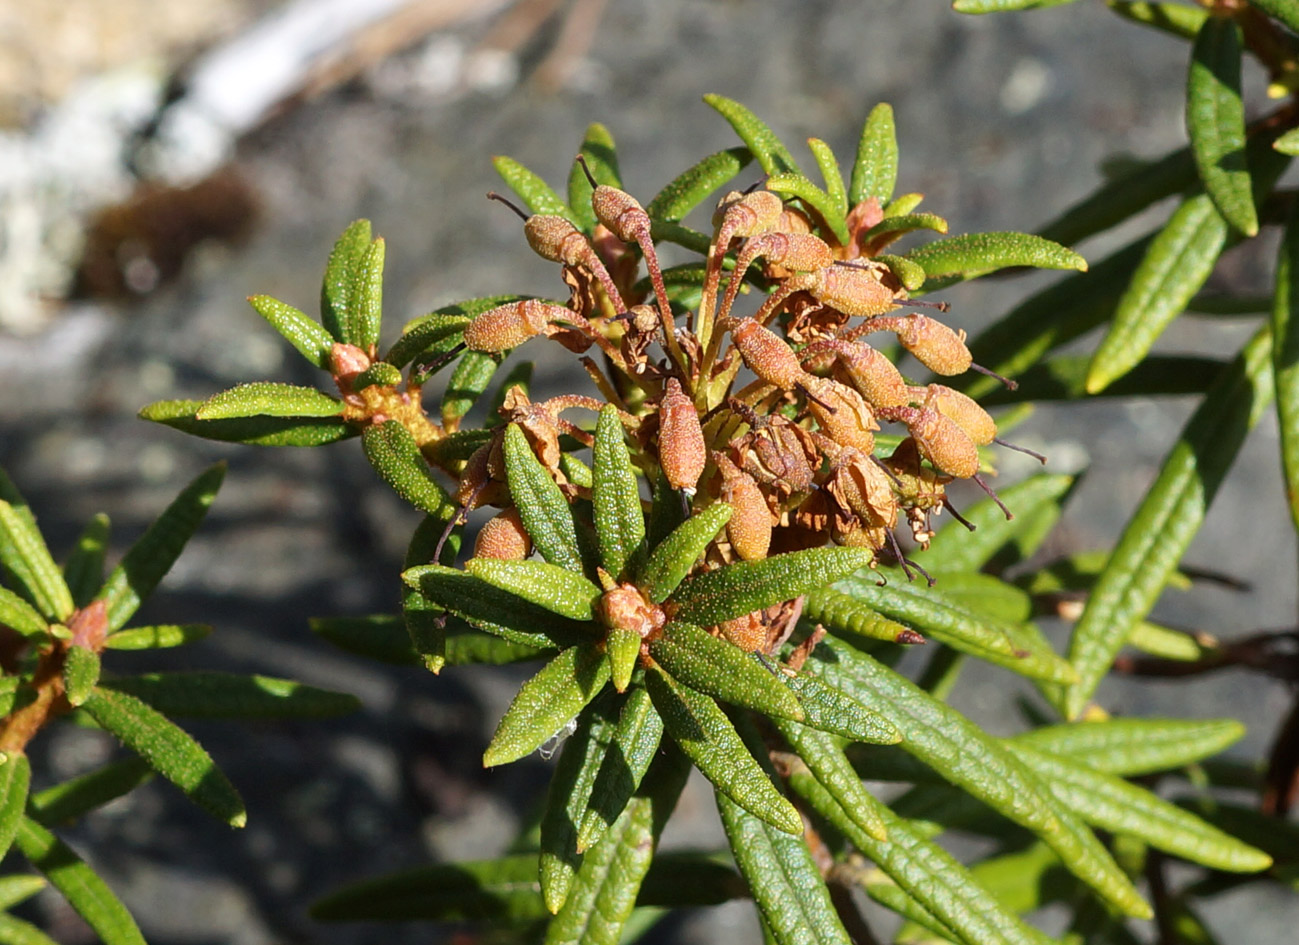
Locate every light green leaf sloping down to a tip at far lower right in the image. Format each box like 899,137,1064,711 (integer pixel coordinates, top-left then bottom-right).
1008,742,1272,872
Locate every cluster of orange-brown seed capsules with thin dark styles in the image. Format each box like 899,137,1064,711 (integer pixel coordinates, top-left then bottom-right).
459,159,1009,595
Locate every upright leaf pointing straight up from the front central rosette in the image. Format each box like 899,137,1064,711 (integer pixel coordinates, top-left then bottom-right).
591,406,646,580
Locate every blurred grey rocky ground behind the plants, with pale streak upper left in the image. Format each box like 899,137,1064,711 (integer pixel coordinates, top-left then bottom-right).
0,0,1299,945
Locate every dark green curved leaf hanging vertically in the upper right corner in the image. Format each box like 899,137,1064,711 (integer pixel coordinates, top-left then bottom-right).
1186,16,1259,237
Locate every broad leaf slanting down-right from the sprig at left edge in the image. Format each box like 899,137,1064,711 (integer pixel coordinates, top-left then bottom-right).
82,686,248,827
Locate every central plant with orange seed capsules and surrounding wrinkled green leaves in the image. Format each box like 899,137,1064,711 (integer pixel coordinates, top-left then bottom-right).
134,85,1270,945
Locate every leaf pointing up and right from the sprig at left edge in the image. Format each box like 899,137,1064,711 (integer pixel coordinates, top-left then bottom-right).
99,463,226,630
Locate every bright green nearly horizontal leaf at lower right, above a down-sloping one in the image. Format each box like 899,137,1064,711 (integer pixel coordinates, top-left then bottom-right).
1015,719,1244,777
